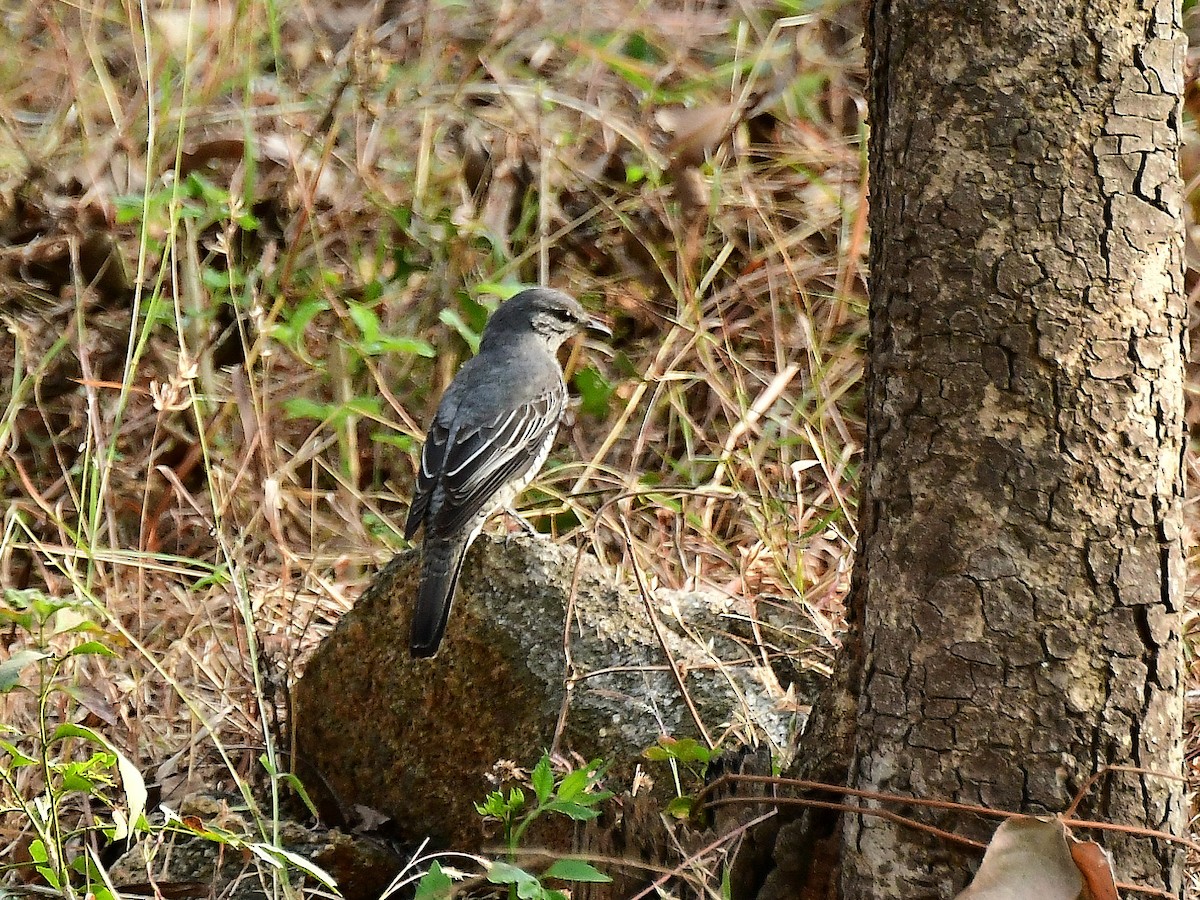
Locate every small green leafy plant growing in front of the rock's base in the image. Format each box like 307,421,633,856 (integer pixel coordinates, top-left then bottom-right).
416,754,612,900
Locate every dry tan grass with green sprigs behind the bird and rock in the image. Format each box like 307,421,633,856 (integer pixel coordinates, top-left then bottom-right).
0,0,1190,897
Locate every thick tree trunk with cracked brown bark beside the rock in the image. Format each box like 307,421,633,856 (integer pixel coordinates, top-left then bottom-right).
739,0,1184,898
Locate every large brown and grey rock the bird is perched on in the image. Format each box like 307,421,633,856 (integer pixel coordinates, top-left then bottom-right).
294,535,794,851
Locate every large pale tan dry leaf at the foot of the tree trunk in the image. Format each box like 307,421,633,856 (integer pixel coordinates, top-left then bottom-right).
956,816,1086,900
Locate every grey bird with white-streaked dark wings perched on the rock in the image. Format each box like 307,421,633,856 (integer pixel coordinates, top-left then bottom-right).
404,288,612,656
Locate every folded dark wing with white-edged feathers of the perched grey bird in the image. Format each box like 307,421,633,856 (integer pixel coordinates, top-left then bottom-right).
404,385,566,535
